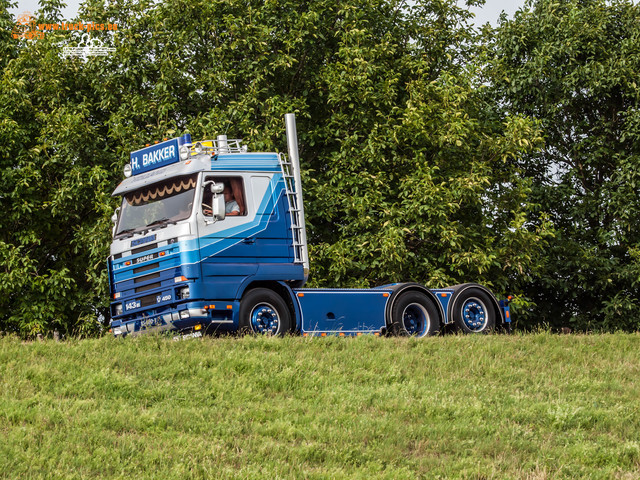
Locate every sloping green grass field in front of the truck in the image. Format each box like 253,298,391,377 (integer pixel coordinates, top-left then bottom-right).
0,333,640,479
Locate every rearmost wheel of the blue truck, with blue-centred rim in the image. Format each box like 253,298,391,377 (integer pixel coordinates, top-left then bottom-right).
451,287,498,333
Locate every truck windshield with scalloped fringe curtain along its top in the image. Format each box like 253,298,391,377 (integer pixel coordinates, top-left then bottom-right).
116,174,197,236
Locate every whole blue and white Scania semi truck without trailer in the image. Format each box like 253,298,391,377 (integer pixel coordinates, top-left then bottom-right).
108,114,511,337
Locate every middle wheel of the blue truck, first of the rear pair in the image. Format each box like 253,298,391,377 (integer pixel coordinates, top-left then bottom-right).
391,292,440,337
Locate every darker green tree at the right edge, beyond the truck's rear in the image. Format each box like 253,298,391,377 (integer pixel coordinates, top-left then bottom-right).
490,0,640,329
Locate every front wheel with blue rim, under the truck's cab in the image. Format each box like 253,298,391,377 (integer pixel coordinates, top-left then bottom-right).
240,288,291,336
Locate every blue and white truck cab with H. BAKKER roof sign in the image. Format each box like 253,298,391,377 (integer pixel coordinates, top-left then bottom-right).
108,137,306,335
